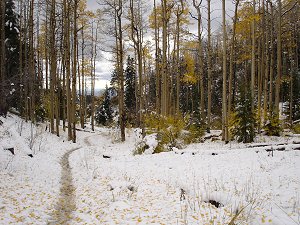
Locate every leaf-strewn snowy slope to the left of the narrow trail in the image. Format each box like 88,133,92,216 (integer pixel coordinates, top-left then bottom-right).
0,115,77,225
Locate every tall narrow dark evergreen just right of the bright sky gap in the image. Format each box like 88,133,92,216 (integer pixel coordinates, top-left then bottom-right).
125,56,136,123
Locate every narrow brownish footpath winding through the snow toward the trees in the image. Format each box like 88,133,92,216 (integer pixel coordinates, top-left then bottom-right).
48,148,80,225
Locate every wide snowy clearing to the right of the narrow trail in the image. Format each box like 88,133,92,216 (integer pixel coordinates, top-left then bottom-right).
72,127,300,225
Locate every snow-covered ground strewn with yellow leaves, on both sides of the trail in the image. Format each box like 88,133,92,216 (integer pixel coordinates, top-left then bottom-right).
0,116,300,225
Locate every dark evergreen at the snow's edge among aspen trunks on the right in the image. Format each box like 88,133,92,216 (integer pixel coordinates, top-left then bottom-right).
230,88,256,143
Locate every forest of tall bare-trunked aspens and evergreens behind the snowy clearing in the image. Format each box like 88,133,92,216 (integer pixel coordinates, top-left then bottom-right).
0,0,300,146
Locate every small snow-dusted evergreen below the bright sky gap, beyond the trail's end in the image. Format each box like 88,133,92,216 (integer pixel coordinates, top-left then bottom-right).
95,86,113,126
